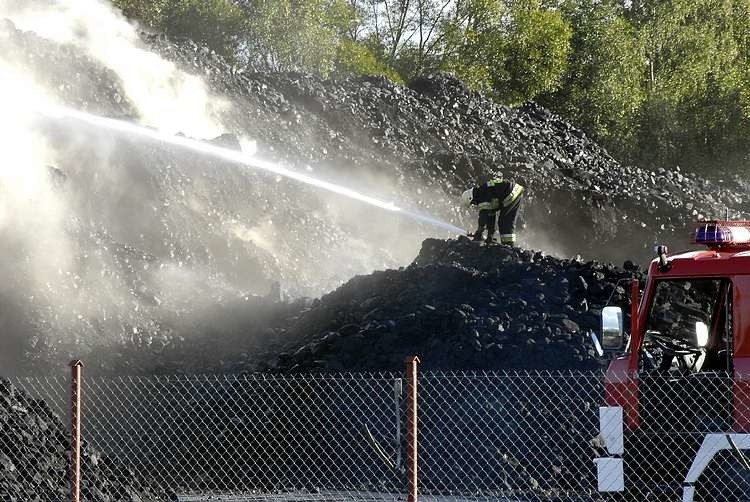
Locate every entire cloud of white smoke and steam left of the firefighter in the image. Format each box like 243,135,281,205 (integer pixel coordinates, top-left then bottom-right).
0,0,464,367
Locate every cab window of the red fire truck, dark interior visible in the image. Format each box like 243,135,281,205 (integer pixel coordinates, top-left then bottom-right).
640,279,731,373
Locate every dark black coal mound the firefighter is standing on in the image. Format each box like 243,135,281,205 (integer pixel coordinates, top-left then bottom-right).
266,237,643,372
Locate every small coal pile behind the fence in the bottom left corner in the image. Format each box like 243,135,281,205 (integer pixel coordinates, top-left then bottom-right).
0,380,169,502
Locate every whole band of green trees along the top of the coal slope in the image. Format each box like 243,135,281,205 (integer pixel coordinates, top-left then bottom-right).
113,0,750,175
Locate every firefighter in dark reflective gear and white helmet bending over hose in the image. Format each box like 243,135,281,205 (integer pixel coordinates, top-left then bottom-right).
461,179,524,246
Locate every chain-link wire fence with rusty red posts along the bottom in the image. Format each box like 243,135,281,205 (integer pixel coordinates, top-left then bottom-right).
0,366,750,502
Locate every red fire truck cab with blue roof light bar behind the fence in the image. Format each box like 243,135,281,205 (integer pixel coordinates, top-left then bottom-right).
592,220,750,502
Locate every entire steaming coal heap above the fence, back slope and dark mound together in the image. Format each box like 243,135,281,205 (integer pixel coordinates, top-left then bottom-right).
0,19,747,372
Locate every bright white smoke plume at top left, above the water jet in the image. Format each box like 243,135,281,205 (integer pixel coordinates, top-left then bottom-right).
0,0,228,138
